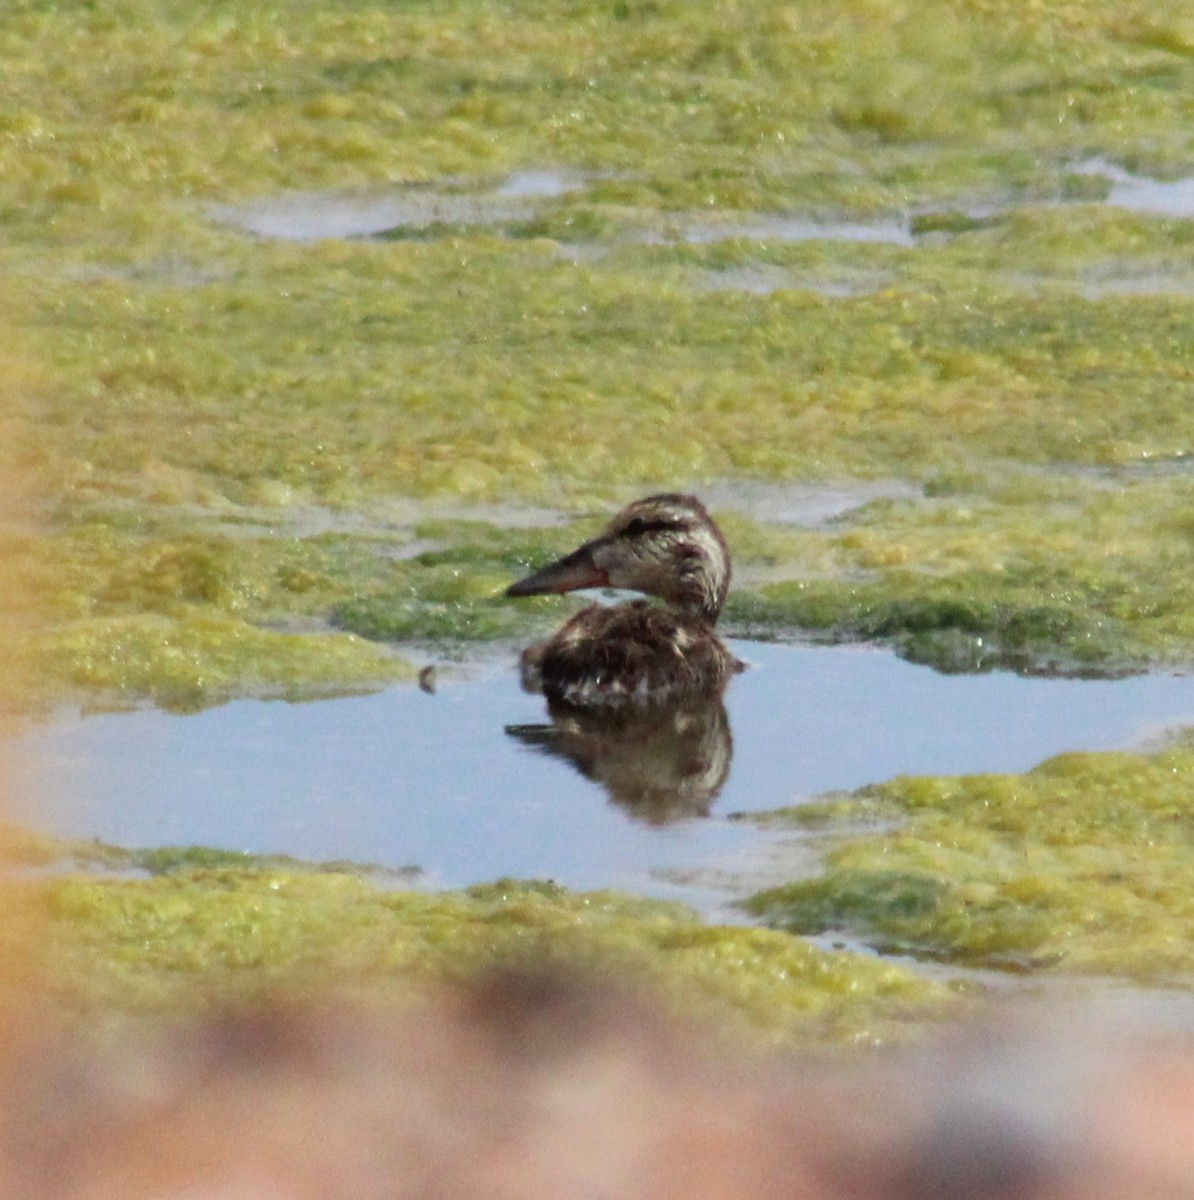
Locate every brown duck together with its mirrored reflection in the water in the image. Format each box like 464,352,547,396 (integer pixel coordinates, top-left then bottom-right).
506,493,743,821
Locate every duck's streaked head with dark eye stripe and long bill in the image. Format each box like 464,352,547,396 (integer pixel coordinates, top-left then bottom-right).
506,493,730,625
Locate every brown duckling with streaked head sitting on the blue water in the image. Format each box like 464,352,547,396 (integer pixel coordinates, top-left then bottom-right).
506,492,743,709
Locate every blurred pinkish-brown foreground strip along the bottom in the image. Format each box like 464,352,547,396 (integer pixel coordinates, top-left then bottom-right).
0,970,1194,1200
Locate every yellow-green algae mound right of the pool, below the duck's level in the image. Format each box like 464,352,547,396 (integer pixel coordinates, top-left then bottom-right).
748,736,1194,988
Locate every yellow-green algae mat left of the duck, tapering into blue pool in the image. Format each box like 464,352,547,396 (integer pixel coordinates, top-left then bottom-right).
23,514,427,708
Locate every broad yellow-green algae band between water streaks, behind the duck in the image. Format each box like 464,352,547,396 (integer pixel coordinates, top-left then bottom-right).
16,247,1194,504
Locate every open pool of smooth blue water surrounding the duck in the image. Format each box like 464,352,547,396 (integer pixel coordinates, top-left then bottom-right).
10,642,1194,913
